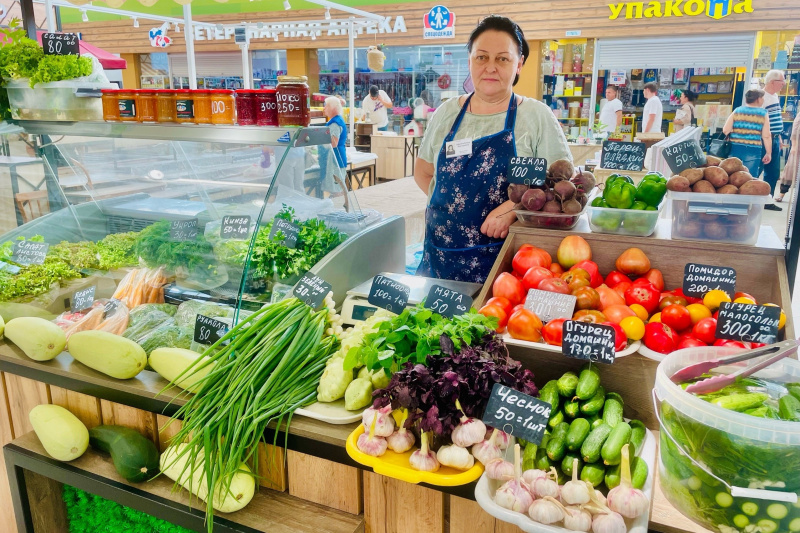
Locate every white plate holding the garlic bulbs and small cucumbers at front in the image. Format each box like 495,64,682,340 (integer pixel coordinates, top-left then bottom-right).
475,429,657,533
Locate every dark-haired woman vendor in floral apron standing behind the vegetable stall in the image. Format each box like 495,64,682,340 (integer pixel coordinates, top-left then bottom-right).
414,15,572,283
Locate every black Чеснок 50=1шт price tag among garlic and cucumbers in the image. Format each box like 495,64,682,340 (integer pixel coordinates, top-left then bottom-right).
482,383,553,446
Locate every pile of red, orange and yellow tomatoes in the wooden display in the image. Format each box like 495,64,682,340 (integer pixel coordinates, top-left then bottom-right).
479,236,786,354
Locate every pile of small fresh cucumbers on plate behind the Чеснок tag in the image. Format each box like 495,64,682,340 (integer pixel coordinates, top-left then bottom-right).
522,363,648,489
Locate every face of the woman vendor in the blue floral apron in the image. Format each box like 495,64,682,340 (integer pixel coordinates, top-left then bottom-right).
469,30,522,99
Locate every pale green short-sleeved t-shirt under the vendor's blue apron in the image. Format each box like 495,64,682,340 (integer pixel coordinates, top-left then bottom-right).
419,98,572,198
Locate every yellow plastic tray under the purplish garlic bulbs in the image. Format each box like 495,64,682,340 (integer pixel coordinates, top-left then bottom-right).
346,424,483,487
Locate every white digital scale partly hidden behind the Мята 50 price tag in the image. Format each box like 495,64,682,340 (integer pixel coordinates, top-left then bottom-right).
341,272,483,325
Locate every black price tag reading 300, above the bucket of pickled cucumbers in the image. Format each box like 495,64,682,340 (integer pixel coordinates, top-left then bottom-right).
715,302,781,344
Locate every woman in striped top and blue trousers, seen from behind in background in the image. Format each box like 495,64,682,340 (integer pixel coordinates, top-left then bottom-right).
722,89,772,178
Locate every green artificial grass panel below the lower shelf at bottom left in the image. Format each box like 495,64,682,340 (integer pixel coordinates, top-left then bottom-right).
63,485,190,533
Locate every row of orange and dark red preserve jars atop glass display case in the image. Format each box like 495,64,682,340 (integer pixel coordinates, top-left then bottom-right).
102,76,310,126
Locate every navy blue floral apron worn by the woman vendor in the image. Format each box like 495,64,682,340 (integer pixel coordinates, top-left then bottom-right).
417,94,517,283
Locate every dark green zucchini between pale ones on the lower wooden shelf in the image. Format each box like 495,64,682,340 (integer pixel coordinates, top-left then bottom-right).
89,425,158,483
